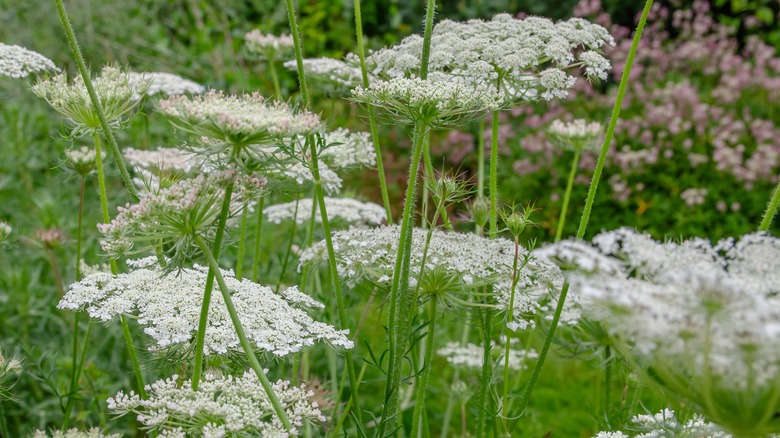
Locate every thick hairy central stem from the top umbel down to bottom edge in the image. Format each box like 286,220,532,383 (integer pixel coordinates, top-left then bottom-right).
379,124,425,436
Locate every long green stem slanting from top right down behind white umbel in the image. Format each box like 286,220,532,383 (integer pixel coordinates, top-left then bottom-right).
513,0,653,426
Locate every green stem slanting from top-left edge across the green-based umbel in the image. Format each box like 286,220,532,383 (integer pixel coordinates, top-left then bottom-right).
54,0,138,202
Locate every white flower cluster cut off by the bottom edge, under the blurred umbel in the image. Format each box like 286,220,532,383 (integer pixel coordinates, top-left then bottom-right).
594,409,732,438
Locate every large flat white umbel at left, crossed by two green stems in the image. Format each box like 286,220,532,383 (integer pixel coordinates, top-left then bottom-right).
58,257,352,357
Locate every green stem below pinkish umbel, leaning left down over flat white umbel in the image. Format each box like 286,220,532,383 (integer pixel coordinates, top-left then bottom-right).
192,180,234,391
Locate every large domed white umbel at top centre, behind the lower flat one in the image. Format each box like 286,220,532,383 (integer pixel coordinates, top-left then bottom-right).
366,14,615,100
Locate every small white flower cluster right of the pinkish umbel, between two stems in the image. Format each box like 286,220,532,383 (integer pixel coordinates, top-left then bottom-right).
321,128,376,169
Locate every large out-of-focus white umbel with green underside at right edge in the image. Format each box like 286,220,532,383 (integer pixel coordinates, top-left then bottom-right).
544,229,780,436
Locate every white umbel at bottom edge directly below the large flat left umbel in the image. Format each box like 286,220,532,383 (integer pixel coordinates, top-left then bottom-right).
108,371,325,437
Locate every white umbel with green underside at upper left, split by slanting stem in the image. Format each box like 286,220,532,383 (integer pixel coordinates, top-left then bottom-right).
32,66,145,135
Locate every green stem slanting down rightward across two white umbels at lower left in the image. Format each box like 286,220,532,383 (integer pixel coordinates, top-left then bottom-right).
195,236,292,431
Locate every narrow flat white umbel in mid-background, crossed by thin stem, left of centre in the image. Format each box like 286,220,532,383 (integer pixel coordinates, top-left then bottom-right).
263,197,387,226
